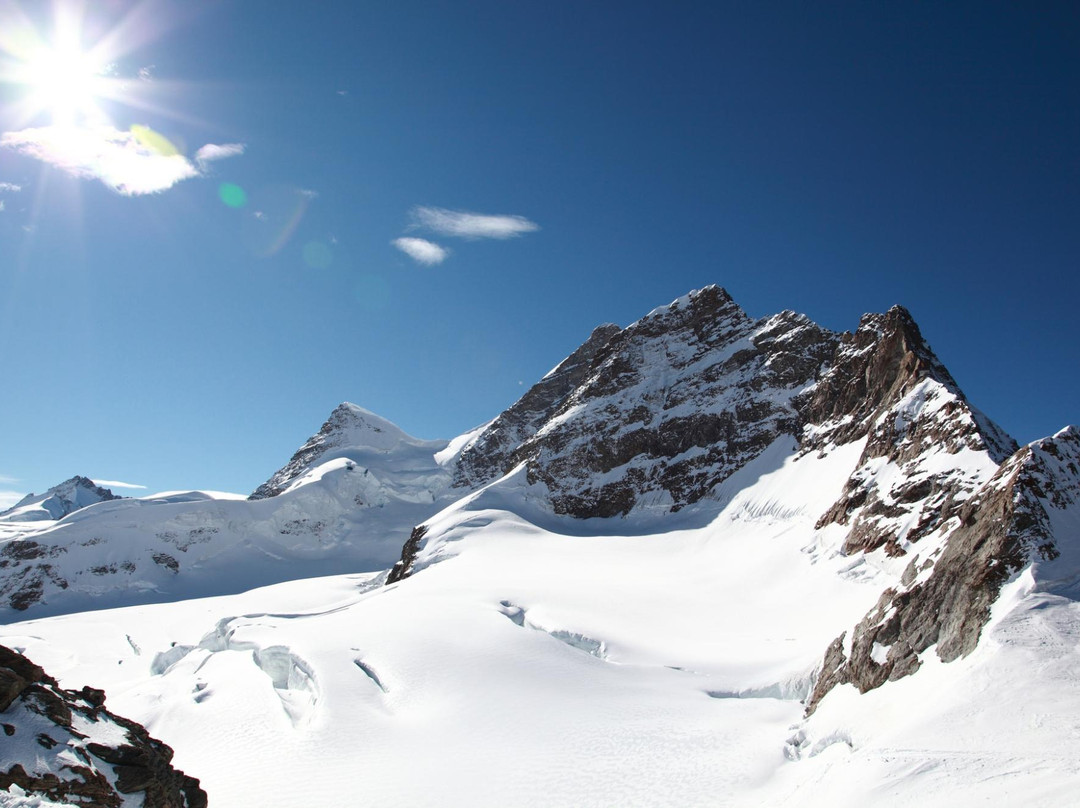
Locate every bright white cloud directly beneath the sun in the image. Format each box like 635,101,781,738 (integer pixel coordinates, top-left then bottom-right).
0,126,243,197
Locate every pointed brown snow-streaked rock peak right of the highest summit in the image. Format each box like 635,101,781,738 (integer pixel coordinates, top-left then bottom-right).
800,306,1016,555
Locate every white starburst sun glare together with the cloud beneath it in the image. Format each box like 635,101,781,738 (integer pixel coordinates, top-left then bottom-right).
0,0,243,196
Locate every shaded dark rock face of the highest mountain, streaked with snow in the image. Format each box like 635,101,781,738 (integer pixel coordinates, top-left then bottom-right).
459,286,837,517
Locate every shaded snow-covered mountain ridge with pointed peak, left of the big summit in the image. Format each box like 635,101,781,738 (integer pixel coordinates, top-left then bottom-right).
0,403,457,619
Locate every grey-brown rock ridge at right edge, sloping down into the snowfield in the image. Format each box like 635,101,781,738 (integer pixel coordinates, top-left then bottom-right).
808,427,1080,712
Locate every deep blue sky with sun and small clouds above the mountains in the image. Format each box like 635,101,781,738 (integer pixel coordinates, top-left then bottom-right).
0,0,1080,505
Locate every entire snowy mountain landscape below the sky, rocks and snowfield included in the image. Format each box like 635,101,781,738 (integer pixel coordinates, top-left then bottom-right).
0,286,1080,808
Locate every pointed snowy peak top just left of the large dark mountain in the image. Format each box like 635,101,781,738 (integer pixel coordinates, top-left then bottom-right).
251,402,447,499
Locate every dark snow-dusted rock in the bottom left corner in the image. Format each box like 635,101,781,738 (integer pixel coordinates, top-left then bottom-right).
0,646,207,808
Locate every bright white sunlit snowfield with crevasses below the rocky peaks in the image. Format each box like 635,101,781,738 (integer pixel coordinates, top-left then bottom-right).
0,439,1080,807
